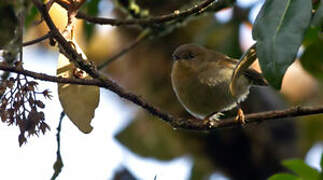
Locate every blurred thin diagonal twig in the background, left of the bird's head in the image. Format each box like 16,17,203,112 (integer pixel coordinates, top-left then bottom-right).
98,29,150,69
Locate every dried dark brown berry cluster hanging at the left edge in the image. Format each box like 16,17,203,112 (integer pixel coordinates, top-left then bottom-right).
0,71,52,146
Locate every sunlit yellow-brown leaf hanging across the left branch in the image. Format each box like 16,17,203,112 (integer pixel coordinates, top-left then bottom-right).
57,41,100,133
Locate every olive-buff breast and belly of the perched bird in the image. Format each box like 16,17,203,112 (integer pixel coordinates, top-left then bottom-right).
171,63,248,119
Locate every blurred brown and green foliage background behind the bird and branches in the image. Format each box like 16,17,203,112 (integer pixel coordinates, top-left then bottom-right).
0,0,323,179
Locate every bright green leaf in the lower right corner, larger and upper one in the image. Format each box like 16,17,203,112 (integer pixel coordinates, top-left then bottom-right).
282,159,320,180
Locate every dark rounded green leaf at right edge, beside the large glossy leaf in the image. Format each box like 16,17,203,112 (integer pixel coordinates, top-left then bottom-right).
301,41,323,80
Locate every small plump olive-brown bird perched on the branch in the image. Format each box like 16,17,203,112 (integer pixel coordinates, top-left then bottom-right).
171,43,268,124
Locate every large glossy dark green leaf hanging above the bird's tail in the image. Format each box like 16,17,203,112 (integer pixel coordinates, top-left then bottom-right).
252,0,312,89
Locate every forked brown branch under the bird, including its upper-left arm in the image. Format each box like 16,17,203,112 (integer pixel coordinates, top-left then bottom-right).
27,0,323,130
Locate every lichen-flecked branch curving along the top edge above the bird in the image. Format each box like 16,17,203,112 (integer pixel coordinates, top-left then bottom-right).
53,0,232,26
